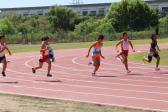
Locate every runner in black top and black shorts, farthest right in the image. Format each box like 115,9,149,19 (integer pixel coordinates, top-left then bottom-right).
143,34,160,71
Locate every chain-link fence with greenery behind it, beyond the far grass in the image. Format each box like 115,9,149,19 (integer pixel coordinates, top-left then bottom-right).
1,28,168,44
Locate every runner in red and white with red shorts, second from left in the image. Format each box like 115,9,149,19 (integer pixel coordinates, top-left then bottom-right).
32,36,52,77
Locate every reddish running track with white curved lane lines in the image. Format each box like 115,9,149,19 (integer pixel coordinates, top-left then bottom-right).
0,44,168,112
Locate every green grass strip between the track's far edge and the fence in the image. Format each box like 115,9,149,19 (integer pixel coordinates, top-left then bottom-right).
8,38,168,53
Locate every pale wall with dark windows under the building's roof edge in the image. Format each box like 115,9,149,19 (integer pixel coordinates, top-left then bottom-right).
1,2,168,16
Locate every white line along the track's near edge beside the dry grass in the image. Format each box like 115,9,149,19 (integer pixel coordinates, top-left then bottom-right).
0,91,167,112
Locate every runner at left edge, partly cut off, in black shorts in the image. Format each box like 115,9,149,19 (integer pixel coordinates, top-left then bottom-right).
0,35,12,77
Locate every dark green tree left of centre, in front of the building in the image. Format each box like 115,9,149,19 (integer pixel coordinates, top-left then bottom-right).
47,5,78,30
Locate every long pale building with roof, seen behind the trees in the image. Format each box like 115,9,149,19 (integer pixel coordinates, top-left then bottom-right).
0,0,168,16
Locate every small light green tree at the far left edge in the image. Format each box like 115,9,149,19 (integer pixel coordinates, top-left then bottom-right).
0,17,16,34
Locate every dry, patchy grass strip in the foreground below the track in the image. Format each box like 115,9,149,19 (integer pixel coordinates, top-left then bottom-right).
0,94,155,112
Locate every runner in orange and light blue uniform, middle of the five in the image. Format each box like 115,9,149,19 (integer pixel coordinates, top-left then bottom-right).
86,35,104,76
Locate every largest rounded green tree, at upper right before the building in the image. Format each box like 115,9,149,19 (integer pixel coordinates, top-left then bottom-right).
105,0,158,29
